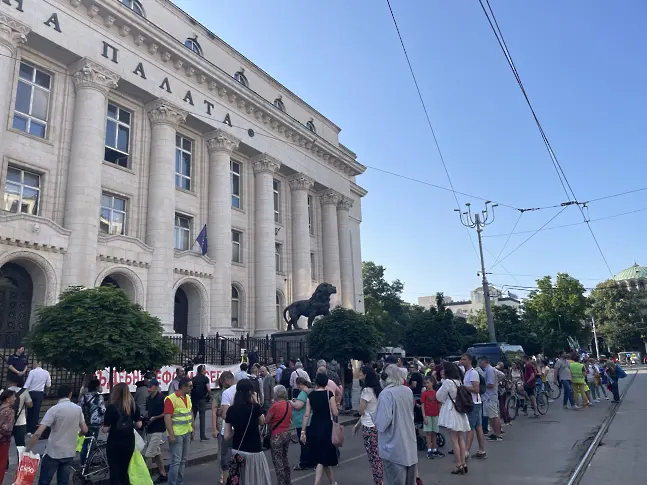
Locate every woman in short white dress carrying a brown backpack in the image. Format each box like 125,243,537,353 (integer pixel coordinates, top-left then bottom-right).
436,362,470,475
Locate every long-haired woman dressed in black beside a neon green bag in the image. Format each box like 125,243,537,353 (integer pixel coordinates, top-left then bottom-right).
102,382,142,485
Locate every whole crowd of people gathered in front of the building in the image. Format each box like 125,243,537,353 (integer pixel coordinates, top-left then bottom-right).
0,348,626,485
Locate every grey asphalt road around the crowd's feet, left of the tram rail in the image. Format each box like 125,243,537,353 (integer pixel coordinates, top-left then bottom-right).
177,379,630,485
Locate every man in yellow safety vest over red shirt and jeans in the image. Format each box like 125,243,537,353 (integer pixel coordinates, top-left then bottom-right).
164,377,193,485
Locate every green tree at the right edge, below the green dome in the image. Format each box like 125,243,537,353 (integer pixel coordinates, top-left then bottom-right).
589,281,647,350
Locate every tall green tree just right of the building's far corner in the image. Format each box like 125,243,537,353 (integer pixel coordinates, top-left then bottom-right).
362,261,409,345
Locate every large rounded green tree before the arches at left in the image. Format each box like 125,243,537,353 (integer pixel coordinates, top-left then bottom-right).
27,287,179,376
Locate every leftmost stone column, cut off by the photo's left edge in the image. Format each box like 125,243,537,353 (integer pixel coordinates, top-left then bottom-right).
0,13,31,160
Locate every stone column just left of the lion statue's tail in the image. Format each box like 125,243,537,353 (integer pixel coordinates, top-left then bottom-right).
252,153,281,336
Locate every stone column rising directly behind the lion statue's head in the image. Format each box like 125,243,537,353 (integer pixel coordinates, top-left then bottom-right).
319,189,342,308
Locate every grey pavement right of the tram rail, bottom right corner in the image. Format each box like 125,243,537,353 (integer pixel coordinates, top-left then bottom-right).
581,368,647,485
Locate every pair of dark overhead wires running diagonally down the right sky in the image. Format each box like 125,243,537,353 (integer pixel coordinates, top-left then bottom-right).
479,0,613,275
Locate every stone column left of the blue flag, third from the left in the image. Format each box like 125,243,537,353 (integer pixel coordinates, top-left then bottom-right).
146,99,187,333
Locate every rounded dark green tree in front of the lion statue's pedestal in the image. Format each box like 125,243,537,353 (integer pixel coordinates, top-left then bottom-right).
307,307,382,362
